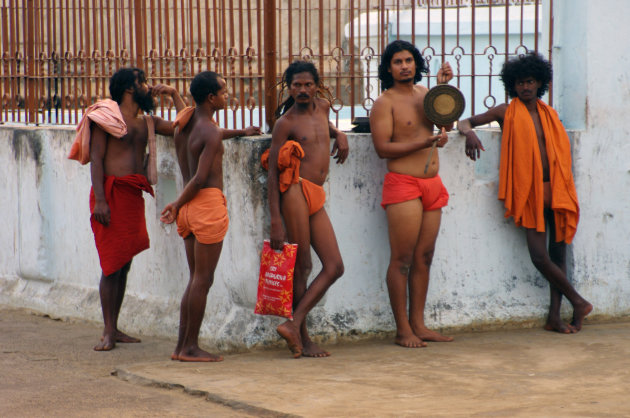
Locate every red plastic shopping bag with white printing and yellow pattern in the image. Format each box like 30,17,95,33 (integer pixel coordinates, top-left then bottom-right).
254,240,297,319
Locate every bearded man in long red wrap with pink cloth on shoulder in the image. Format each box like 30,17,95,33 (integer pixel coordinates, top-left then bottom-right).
69,68,184,351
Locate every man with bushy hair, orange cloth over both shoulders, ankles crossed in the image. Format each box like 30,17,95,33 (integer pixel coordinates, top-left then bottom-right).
458,53,593,334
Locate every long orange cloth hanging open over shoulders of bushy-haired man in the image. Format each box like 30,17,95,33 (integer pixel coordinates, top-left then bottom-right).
499,98,580,244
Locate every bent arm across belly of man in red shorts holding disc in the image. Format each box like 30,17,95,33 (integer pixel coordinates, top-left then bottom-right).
370,96,444,158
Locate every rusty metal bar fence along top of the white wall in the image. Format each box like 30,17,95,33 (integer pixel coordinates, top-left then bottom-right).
0,0,553,127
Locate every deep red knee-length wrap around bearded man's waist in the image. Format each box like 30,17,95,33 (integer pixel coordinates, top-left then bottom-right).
90,174,153,276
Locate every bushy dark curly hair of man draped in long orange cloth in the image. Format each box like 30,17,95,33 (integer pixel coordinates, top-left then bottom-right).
500,52,553,99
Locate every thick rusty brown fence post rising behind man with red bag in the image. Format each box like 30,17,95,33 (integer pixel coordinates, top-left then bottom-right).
264,0,277,131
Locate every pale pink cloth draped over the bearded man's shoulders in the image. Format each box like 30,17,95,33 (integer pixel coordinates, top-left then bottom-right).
68,99,157,184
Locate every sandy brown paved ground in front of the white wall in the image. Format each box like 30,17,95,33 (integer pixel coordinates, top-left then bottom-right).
0,308,630,417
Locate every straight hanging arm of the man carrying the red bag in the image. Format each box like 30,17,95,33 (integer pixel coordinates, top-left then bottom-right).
267,118,290,250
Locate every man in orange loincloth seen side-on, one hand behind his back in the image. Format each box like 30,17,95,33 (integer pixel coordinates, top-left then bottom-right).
161,71,237,362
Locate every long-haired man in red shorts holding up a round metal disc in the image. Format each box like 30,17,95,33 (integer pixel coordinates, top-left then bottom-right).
370,40,453,348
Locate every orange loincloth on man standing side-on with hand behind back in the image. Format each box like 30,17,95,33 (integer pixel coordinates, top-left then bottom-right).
177,187,230,244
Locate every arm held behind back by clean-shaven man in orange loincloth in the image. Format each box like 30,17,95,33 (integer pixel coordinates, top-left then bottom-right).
160,126,221,224
